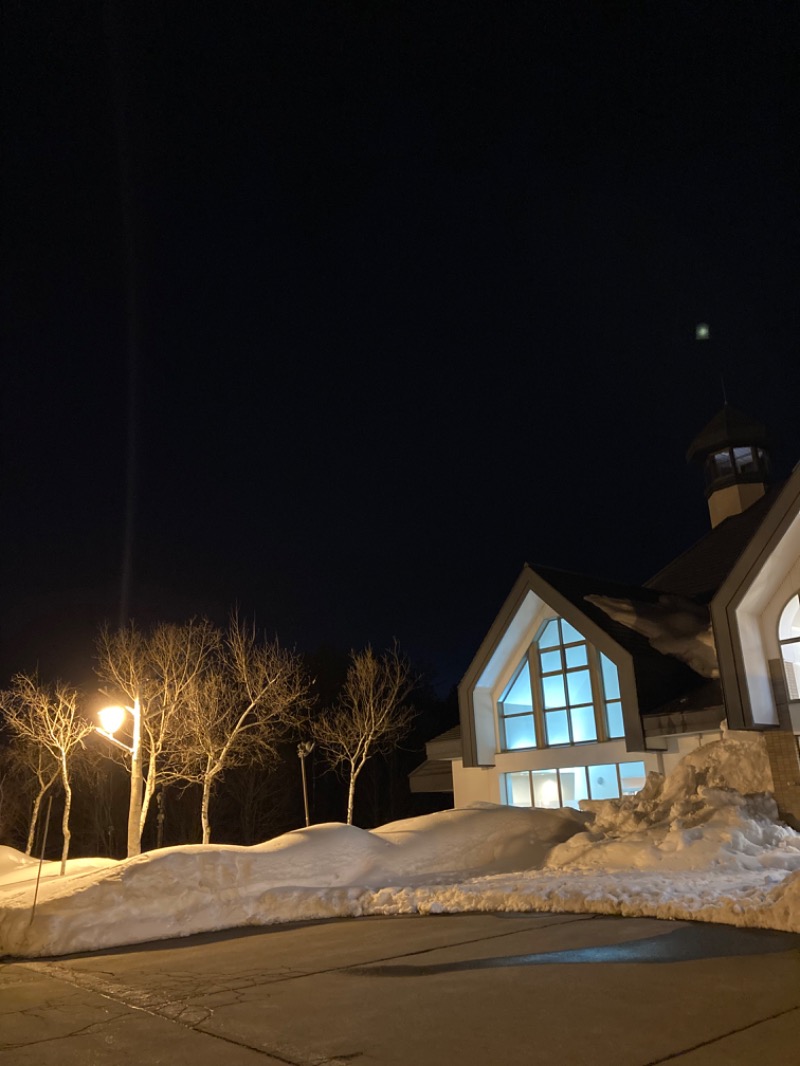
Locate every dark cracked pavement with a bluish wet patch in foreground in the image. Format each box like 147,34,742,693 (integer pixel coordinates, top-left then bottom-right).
0,915,800,1066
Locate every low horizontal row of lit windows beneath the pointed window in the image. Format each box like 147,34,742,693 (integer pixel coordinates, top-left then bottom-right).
502,762,646,810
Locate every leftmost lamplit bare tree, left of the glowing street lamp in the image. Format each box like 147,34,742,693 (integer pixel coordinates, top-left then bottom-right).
0,674,92,874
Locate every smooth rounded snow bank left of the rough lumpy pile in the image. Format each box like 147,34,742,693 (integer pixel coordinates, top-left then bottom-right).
0,805,585,956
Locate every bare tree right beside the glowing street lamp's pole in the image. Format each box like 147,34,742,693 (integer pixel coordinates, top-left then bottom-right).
97,619,221,856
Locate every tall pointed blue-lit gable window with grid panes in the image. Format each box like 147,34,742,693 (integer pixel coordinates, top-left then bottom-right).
497,618,625,754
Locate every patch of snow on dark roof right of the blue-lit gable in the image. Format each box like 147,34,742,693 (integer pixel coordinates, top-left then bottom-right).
586,594,719,678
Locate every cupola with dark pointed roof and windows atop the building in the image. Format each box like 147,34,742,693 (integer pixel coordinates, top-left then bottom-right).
686,403,769,527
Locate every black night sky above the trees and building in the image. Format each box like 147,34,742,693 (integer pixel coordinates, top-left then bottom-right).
0,0,800,691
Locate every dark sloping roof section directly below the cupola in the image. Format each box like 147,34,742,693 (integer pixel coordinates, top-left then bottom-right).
644,487,779,603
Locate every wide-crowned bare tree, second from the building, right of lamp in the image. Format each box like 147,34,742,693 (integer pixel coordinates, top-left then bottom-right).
178,615,309,844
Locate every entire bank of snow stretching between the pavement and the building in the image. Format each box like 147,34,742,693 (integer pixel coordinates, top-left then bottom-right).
0,733,800,957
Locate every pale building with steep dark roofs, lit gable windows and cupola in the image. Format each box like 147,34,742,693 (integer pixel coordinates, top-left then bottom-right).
411,405,800,821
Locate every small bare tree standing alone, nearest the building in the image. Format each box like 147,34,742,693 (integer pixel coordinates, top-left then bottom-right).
313,644,416,825
